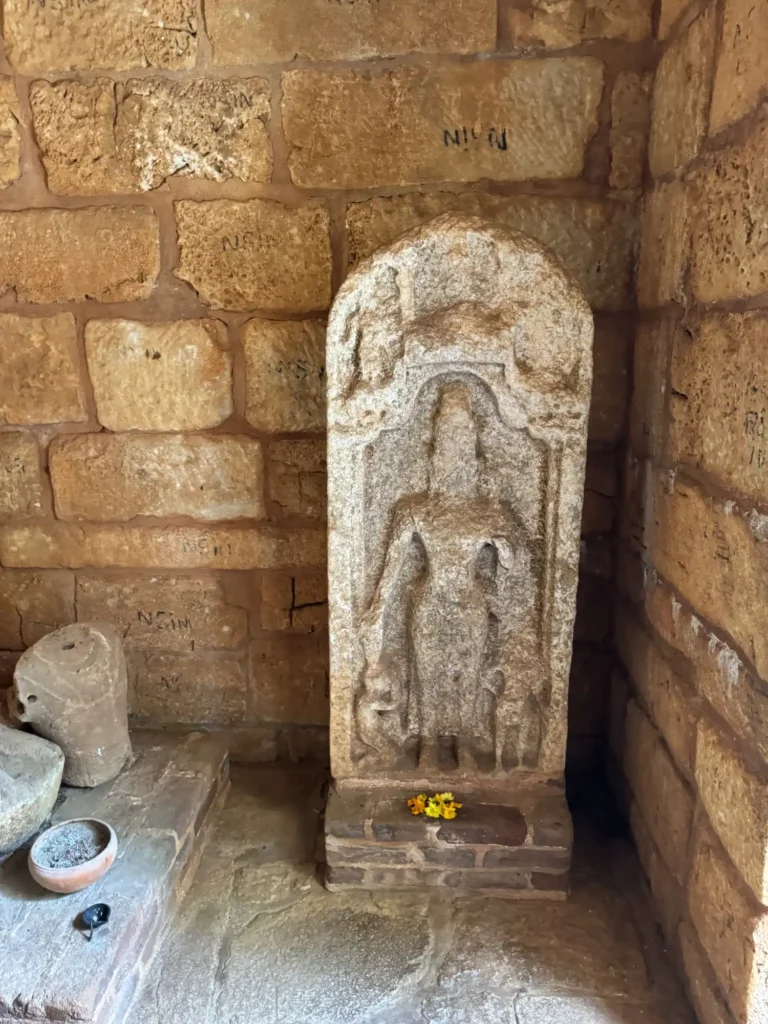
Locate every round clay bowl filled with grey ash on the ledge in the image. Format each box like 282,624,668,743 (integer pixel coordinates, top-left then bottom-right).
28,818,118,893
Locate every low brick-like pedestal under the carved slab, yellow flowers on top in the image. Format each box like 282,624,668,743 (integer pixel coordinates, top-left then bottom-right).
326,785,573,899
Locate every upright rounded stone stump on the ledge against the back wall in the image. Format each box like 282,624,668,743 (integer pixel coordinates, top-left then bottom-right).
13,623,131,786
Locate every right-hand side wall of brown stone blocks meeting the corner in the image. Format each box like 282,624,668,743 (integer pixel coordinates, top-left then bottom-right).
611,0,768,1024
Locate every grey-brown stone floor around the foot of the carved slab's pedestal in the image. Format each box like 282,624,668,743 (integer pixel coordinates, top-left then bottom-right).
124,767,692,1024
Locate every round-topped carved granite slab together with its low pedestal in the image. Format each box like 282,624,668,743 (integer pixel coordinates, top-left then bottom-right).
326,215,593,898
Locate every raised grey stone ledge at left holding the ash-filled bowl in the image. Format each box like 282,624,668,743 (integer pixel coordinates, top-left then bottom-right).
0,733,228,1024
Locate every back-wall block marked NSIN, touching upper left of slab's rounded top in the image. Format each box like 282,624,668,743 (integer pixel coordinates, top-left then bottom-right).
175,200,331,312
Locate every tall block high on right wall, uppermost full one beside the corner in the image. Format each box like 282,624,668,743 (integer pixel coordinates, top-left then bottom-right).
648,7,717,177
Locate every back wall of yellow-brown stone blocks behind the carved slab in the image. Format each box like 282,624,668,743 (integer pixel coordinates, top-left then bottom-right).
0,0,654,767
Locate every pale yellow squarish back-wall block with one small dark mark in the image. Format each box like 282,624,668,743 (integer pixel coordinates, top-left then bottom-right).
85,319,233,430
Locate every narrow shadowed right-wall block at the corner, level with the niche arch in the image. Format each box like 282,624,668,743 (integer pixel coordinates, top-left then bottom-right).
630,321,675,458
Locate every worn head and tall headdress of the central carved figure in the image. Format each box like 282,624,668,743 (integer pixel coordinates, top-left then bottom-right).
429,384,478,498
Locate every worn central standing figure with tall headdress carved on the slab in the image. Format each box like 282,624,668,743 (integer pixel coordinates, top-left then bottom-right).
357,383,527,771
